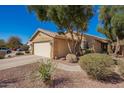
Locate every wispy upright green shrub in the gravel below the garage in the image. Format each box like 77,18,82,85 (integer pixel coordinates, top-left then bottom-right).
39,60,56,85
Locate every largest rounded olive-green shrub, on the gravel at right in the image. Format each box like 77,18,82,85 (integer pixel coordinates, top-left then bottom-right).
79,53,115,80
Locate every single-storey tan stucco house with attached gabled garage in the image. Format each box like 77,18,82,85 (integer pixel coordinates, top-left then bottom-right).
29,29,107,58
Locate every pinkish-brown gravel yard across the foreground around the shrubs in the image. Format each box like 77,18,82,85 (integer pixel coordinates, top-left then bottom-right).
0,63,124,88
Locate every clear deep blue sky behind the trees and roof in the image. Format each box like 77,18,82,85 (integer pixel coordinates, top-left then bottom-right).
0,6,104,43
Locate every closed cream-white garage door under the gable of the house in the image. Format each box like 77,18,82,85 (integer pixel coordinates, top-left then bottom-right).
34,42,51,58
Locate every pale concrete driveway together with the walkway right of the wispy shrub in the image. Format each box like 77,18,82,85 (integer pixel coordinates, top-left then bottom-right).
0,55,82,72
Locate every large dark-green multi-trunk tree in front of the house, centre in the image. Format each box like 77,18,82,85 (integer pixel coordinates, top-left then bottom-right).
28,5,93,53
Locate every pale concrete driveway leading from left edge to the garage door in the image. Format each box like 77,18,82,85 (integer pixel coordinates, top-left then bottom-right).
0,55,42,70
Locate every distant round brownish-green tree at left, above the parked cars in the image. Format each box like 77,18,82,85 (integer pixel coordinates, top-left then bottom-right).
7,36,22,49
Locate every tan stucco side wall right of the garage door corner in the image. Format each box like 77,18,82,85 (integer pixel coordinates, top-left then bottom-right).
54,38,73,58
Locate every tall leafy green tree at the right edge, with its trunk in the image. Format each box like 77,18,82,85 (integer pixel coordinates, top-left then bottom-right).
98,6,124,55
